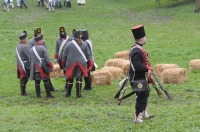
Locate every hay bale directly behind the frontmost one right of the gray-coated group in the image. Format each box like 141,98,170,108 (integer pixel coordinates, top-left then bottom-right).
102,66,124,80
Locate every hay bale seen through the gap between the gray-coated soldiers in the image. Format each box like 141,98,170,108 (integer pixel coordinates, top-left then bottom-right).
50,64,64,78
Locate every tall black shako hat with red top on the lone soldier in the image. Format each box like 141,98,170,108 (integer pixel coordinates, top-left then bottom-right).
131,24,146,39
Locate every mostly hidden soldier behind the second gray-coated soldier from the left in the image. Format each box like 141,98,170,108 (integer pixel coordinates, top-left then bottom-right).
28,28,56,91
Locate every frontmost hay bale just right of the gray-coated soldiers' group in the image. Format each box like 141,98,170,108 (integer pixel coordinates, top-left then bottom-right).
91,69,112,86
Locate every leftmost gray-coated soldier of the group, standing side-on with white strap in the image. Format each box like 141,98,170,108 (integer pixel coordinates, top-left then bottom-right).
16,31,30,96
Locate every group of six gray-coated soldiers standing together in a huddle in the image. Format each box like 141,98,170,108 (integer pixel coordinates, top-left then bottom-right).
16,27,95,98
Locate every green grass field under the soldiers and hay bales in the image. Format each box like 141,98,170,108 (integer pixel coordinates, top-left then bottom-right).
0,0,200,132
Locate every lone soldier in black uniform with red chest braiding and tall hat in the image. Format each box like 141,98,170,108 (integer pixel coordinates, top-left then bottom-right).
129,25,154,123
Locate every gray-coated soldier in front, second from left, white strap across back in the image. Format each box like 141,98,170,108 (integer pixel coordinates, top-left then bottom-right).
29,35,54,98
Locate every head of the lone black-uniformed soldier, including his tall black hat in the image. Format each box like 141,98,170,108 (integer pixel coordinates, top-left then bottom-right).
131,24,146,44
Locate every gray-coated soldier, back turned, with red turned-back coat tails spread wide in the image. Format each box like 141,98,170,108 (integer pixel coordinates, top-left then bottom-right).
62,31,93,98
